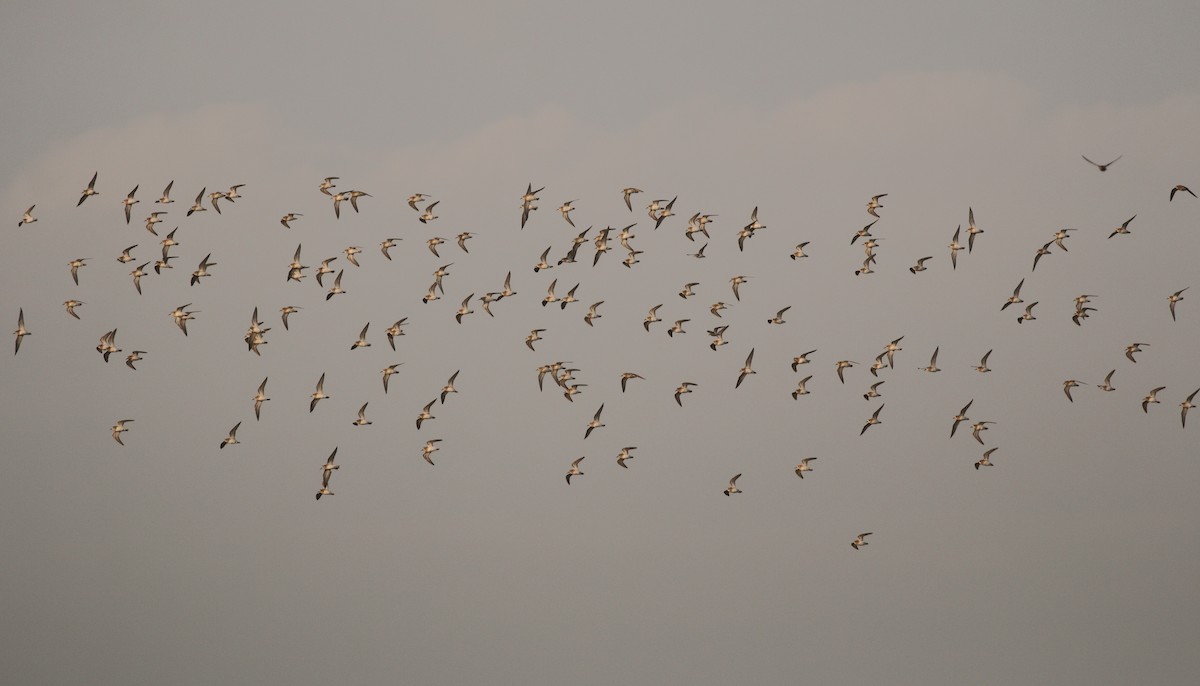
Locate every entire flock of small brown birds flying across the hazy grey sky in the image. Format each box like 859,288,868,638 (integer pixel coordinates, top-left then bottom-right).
4,152,1200,549
